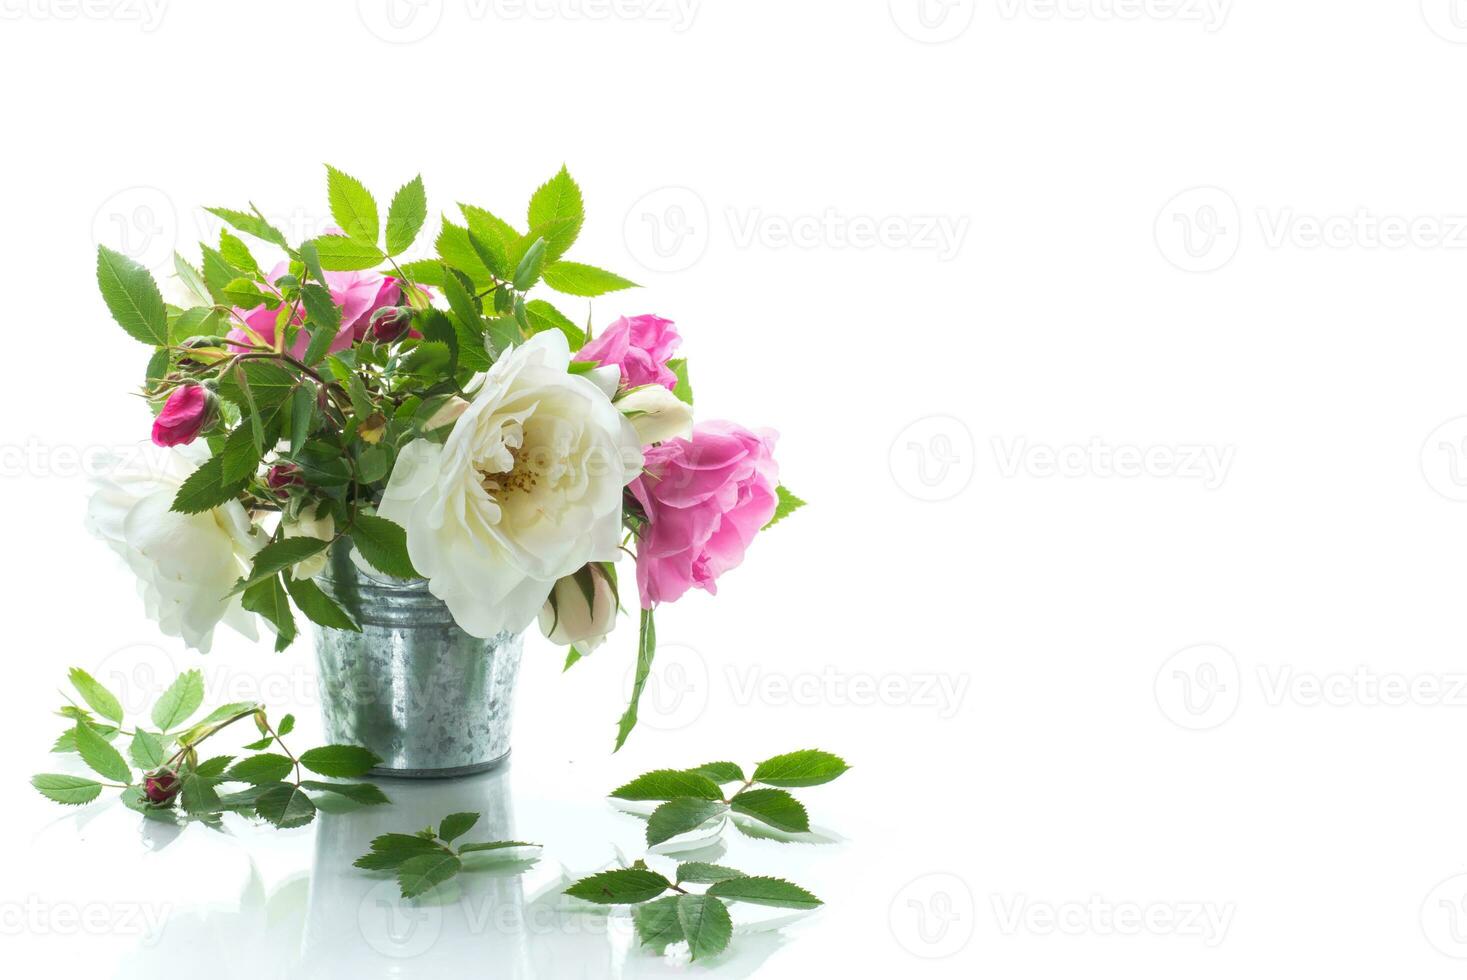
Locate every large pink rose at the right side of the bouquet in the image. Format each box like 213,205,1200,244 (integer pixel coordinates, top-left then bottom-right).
631,423,779,609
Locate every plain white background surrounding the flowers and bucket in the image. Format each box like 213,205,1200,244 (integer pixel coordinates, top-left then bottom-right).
0,0,1467,977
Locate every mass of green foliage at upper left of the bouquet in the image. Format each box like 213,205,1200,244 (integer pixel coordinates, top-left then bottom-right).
97,167,635,650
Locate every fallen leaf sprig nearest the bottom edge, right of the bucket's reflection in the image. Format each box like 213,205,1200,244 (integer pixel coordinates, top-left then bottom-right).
565,861,822,959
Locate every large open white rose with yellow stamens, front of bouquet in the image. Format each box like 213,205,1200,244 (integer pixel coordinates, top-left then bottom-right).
378,330,643,637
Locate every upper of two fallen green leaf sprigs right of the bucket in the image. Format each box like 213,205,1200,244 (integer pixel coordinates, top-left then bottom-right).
610,748,849,846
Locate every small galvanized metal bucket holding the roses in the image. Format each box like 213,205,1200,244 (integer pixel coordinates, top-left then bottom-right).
311,540,524,778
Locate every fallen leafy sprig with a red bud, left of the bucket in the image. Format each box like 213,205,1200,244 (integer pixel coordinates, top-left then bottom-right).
31,668,389,827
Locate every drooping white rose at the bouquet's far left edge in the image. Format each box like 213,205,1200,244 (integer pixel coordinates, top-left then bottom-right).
87,445,264,653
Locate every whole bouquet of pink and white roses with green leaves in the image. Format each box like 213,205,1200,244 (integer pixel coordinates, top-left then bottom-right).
89,167,801,745
